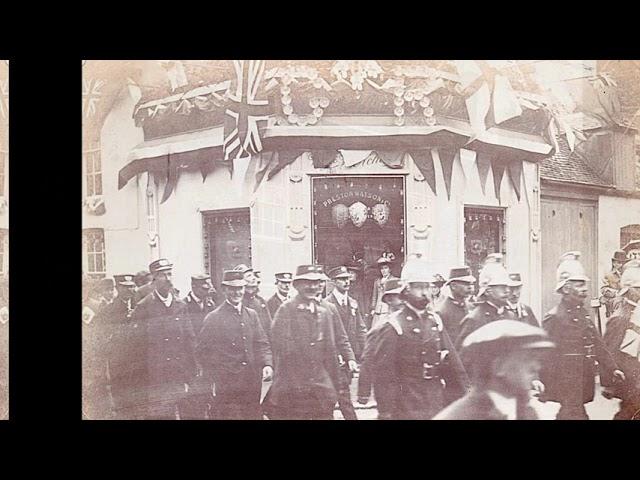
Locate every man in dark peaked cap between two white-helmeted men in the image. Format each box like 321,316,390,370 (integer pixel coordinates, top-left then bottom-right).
436,265,476,340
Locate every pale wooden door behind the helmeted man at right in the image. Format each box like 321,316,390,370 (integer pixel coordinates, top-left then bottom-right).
541,197,599,315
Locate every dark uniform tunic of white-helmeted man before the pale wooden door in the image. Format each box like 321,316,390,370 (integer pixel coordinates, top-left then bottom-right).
541,299,617,407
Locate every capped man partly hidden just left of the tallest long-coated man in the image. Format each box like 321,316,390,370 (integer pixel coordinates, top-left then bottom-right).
105,274,139,419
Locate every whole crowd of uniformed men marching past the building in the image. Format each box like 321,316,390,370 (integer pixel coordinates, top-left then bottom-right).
83,252,640,420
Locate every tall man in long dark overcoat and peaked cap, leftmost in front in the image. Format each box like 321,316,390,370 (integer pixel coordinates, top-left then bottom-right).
131,258,197,420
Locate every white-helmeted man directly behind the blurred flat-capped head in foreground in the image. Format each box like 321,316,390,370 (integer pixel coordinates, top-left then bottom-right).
456,263,515,349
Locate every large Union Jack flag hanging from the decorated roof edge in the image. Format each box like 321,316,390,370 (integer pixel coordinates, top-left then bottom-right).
222,60,270,171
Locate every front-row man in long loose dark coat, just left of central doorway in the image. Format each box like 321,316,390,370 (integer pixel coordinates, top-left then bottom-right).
263,265,340,420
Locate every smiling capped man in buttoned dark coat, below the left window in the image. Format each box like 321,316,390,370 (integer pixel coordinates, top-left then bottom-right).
196,269,273,420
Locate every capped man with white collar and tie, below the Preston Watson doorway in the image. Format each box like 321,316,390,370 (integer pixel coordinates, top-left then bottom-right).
325,266,367,420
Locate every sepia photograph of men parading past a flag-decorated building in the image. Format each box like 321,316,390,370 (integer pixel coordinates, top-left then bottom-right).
81,60,640,420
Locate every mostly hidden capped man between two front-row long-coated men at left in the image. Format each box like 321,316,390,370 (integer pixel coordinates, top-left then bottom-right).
180,273,216,420
